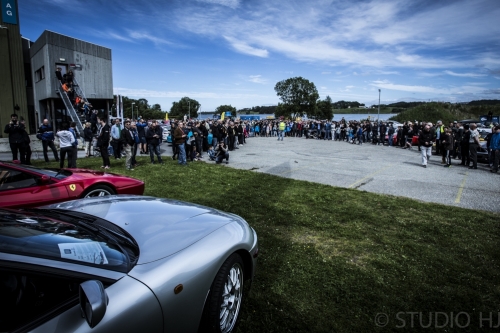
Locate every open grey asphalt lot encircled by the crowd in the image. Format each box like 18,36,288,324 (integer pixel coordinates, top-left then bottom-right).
224,137,500,212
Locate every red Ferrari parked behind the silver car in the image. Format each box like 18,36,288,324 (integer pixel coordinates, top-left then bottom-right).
0,162,144,208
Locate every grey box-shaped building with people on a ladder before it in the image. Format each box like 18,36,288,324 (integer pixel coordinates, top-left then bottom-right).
30,30,113,128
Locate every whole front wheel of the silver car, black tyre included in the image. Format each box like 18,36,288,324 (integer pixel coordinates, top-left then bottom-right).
200,253,244,333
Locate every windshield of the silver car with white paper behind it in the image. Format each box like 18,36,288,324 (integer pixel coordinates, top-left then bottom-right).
0,210,130,273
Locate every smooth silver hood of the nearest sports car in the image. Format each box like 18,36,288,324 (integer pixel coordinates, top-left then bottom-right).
46,195,238,265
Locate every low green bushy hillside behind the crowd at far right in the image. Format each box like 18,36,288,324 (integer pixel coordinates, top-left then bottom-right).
391,101,500,124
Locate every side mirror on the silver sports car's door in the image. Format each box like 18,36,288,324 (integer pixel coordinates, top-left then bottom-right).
79,280,108,328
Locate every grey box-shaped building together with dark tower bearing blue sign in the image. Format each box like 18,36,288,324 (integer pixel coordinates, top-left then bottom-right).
0,0,113,140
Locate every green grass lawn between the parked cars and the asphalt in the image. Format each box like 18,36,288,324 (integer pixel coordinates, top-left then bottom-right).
37,158,500,333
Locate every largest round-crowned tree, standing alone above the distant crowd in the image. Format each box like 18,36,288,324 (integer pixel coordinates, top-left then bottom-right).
274,76,319,119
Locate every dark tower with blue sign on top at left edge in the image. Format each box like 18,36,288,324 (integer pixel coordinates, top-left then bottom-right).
0,0,29,137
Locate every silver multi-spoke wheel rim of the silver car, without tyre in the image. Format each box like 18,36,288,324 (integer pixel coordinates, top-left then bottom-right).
219,262,243,333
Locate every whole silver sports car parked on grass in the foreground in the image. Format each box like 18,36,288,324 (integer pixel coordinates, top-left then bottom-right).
0,196,259,333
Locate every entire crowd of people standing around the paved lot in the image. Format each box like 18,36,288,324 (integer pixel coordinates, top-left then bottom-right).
1,114,500,172
